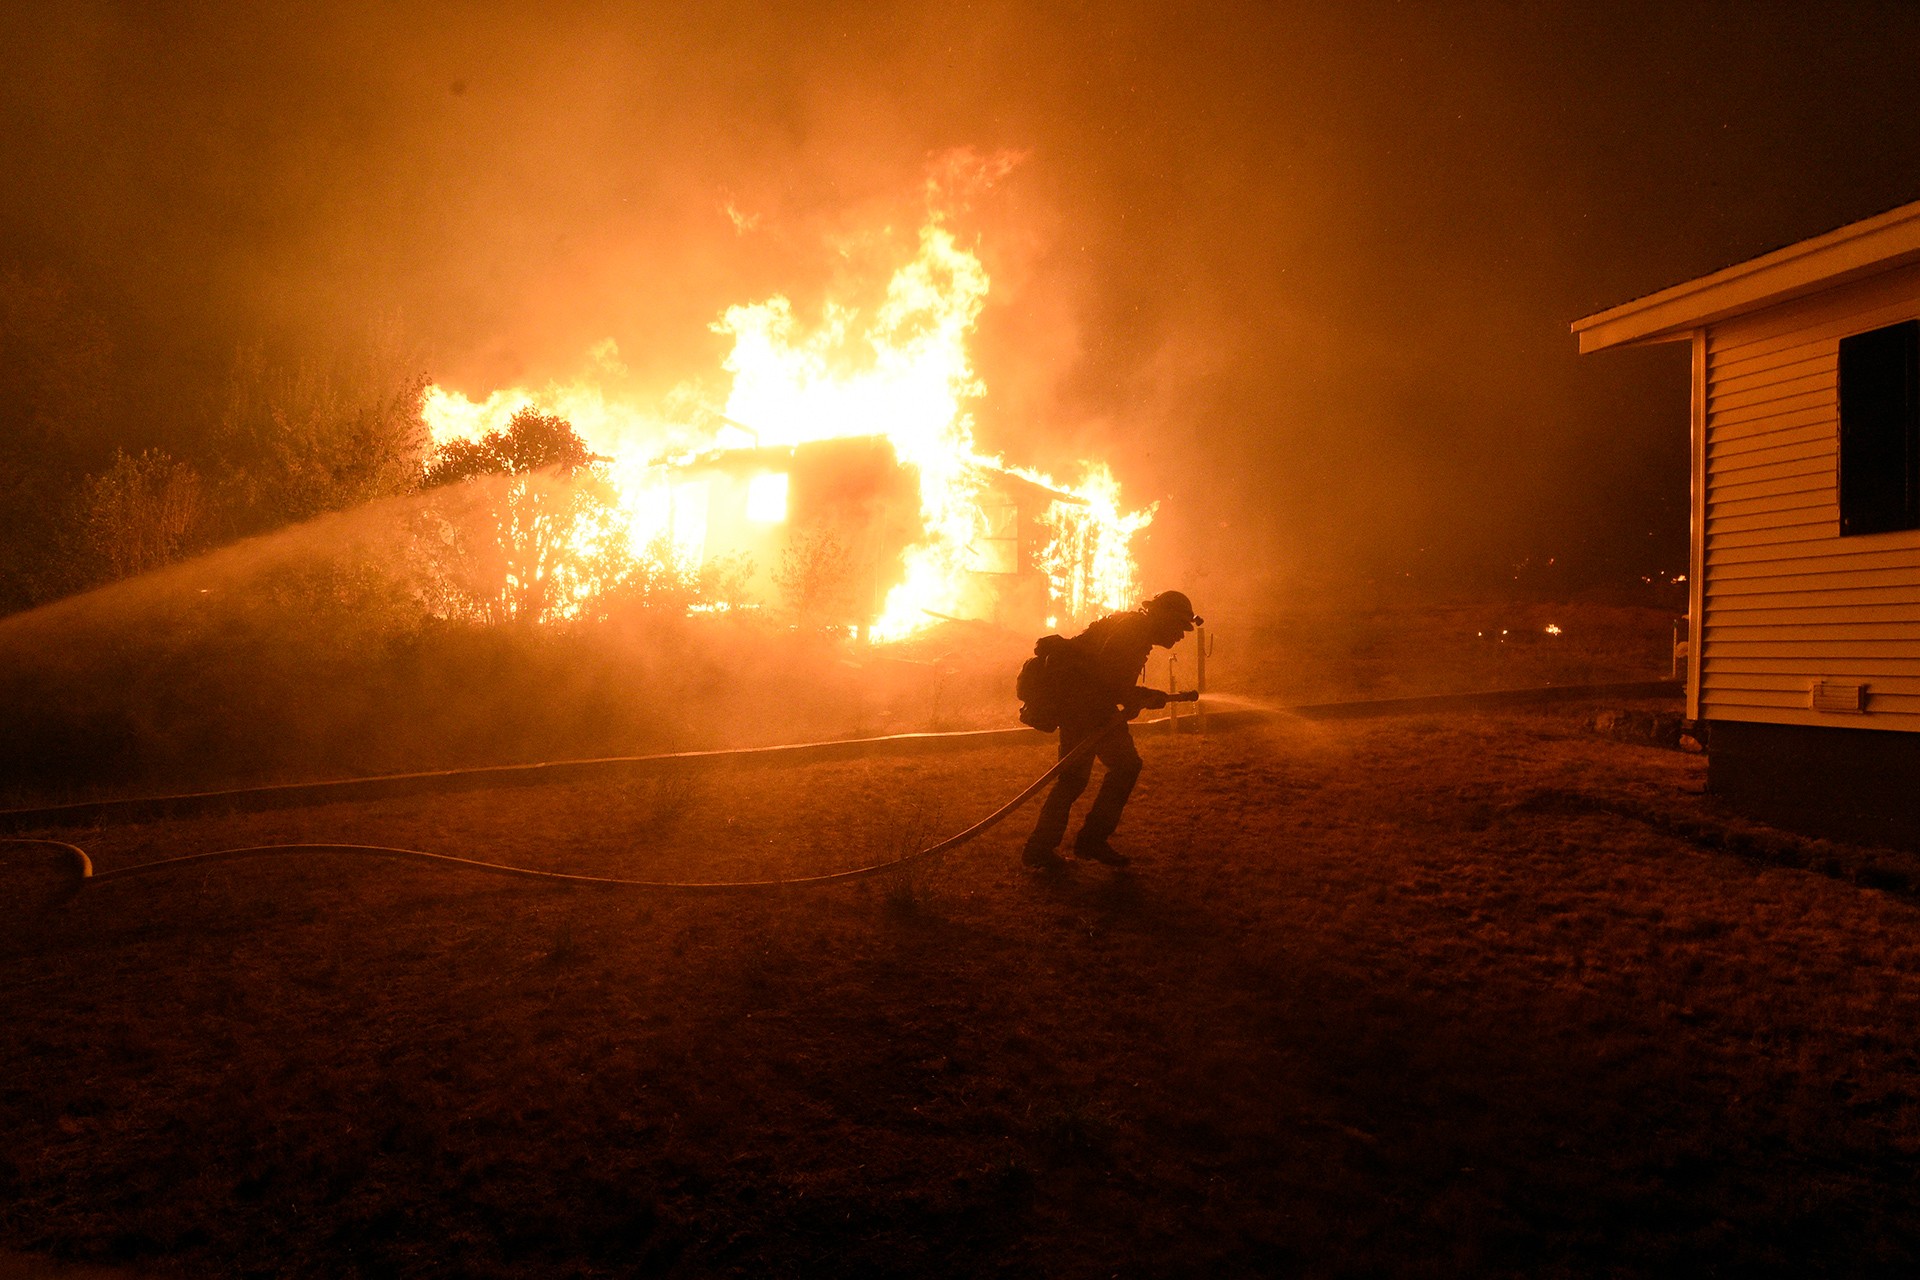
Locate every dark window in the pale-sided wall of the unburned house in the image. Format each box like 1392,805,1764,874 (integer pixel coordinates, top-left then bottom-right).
1839,320,1920,535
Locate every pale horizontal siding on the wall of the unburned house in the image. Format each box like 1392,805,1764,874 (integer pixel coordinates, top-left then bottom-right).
1699,257,1920,731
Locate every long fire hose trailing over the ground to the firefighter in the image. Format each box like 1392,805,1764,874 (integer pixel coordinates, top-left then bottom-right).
0,695,1192,892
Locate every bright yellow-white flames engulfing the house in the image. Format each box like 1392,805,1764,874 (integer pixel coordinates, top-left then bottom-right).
424,217,1152,641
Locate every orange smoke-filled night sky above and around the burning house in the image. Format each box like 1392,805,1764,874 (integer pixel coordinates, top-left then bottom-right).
11,4,1920,614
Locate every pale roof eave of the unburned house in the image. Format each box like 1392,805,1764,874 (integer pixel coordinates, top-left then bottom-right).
1572,201,1920,355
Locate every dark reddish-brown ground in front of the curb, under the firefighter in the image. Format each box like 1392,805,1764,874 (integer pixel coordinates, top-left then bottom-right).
0,708,1920,1276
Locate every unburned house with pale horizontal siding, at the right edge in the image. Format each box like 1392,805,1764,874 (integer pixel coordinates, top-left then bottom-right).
1572,201,1920,839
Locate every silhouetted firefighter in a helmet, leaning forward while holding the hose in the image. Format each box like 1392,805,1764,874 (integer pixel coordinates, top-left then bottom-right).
1023,591,1200,869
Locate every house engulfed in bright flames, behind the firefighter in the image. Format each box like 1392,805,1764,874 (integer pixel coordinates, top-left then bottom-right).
424,219,1152,641
